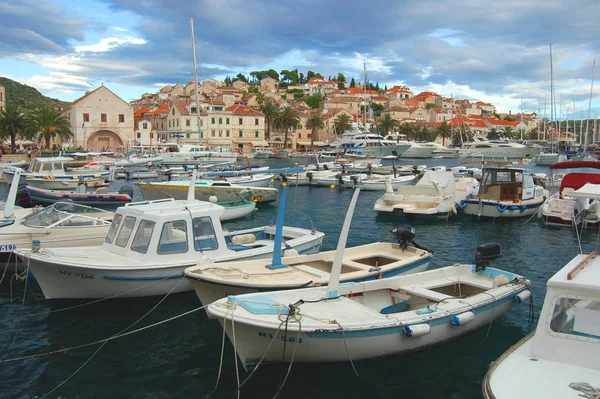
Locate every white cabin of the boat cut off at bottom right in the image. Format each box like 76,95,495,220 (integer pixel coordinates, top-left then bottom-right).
530,252,600,370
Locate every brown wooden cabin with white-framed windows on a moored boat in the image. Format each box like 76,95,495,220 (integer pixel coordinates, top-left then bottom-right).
479,168,535,202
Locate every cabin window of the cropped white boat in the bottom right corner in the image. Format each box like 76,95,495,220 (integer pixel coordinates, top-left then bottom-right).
550,296,600,342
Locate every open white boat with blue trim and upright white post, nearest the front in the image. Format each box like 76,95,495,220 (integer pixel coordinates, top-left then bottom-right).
207,206,529,369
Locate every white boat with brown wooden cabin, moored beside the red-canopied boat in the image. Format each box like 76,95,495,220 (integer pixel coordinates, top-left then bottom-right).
463,167,550,218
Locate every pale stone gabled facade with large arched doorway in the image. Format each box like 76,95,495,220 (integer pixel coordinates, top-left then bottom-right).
65,86,135,151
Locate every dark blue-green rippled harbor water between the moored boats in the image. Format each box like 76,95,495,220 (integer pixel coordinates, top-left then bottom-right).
0,160,598,399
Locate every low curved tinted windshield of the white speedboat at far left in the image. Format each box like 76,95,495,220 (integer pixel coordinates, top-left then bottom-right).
21,202,113,228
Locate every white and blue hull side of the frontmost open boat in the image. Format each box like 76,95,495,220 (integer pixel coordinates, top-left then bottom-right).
218,295,515,368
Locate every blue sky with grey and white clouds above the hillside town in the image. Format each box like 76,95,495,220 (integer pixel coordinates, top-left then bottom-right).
0,0,600,118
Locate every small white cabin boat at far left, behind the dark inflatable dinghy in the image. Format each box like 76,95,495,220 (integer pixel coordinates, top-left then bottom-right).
3,157,110,190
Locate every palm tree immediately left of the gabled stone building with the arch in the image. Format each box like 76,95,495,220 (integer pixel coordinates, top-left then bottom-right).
28,104,73,148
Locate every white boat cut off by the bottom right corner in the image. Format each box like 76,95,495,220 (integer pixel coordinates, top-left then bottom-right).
482,253,600,399
